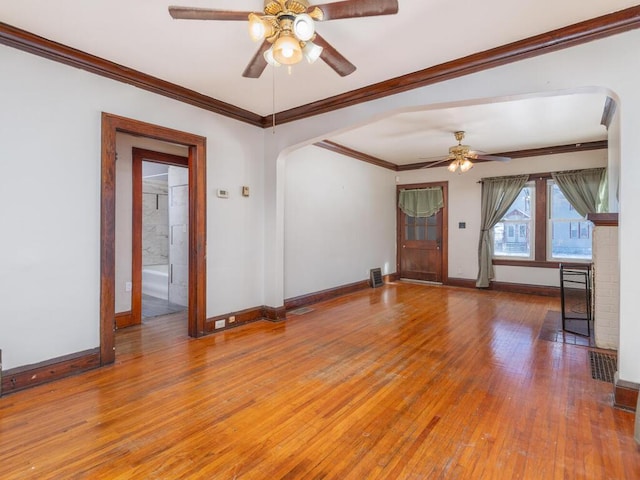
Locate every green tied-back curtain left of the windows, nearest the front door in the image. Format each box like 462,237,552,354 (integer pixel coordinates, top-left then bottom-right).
476,175,529,288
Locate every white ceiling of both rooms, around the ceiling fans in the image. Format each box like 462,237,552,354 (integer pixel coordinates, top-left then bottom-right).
0,0,636,164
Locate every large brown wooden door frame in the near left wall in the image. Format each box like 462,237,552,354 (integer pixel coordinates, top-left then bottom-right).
100,112,207,365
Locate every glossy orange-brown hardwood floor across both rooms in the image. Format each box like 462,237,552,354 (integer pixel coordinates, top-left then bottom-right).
0,283,640,480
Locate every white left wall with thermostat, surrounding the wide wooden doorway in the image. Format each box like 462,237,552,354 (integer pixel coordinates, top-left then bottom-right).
0,46,264,369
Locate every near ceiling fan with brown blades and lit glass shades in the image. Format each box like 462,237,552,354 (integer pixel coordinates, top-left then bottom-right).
169,0,398,78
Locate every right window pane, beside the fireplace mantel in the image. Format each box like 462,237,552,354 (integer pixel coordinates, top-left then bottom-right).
547,180,593,261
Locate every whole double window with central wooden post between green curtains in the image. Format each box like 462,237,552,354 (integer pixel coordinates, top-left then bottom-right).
493,175,593,267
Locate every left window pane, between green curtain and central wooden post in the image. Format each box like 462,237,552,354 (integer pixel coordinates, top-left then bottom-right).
493,182,535,259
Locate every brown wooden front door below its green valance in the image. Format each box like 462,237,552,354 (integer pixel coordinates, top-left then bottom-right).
398,209,443,282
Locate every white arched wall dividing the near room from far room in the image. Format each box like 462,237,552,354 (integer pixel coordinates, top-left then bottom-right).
265,30,640,383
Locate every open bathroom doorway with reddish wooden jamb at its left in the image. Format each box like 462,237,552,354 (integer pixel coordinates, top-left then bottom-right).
131,147,189,324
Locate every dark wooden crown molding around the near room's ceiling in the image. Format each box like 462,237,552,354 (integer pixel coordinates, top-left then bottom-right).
0,5,640,128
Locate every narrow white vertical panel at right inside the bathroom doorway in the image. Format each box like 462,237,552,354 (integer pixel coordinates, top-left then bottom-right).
169,166,189,307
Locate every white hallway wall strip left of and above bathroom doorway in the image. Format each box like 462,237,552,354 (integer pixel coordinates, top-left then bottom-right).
115,133,189,313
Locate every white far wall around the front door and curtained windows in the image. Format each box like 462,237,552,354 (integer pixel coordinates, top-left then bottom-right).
399,150,607,286
